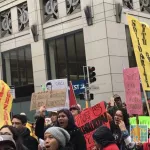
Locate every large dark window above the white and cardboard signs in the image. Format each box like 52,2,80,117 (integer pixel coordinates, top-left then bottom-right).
47,32,86,80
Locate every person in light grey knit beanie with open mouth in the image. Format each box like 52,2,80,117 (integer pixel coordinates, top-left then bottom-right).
44,127,71,150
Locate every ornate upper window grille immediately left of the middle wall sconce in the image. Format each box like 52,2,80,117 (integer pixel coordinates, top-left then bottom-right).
66,0,81,15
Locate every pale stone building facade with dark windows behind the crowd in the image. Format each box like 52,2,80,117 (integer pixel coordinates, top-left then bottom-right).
0,0,150,119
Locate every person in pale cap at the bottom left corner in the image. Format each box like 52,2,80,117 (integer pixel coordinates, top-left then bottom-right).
0,135,17,150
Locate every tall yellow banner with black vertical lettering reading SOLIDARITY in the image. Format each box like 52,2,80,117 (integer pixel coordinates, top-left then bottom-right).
127,15,150,91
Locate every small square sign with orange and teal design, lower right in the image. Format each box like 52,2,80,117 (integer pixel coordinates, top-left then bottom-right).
130,125,148,143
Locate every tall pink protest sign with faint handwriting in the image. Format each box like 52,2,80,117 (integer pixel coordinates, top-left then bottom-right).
123,68,143,115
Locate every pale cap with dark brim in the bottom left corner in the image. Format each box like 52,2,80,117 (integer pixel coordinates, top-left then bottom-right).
0,135,16,148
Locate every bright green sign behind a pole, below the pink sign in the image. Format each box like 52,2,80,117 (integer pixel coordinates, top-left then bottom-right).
130,116,150,129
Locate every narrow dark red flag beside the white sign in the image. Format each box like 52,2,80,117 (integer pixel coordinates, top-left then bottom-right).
69,81,77,107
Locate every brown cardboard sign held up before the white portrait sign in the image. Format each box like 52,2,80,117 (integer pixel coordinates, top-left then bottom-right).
30,89,66,110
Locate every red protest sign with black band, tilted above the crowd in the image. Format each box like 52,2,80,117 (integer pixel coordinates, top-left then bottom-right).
75,102,109,150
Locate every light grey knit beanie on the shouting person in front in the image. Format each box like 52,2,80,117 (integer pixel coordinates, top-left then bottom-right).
45,127,70,147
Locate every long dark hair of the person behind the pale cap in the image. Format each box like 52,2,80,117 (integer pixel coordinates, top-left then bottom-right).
0,125,25,150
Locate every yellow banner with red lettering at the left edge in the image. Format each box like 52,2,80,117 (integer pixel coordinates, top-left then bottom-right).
0,80,13,127
